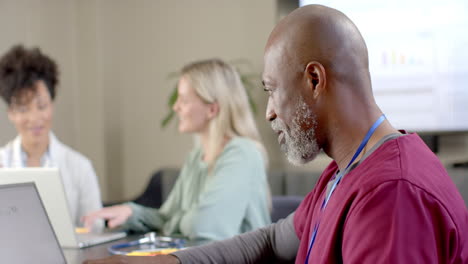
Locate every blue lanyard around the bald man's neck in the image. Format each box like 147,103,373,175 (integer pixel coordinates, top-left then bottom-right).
304,114,386,264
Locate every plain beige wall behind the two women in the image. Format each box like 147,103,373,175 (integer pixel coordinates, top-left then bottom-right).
0,0,282,200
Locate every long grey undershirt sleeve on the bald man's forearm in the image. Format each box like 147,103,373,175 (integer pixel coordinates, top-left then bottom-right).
172,213,299,264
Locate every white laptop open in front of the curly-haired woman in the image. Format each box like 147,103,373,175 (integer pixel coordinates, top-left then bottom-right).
0,168,126,248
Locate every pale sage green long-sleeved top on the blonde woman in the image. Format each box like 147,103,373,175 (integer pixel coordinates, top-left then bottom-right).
123,137,271,240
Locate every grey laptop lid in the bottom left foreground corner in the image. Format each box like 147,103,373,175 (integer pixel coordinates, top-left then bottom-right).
0,182,66,264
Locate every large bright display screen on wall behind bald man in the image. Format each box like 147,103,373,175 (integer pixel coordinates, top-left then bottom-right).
299,0,468,132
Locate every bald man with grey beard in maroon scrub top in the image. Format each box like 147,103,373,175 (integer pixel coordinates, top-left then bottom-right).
84,5,468,264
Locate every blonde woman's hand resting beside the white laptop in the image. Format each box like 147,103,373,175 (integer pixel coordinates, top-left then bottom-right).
81,204,133,229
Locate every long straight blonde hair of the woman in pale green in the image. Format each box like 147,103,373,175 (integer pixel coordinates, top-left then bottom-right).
181,59,268,167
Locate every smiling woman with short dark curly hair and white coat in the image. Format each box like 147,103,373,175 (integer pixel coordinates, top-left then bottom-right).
0,45,102,227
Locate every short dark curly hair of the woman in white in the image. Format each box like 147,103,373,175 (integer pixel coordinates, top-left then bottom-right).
0,45,59,105
